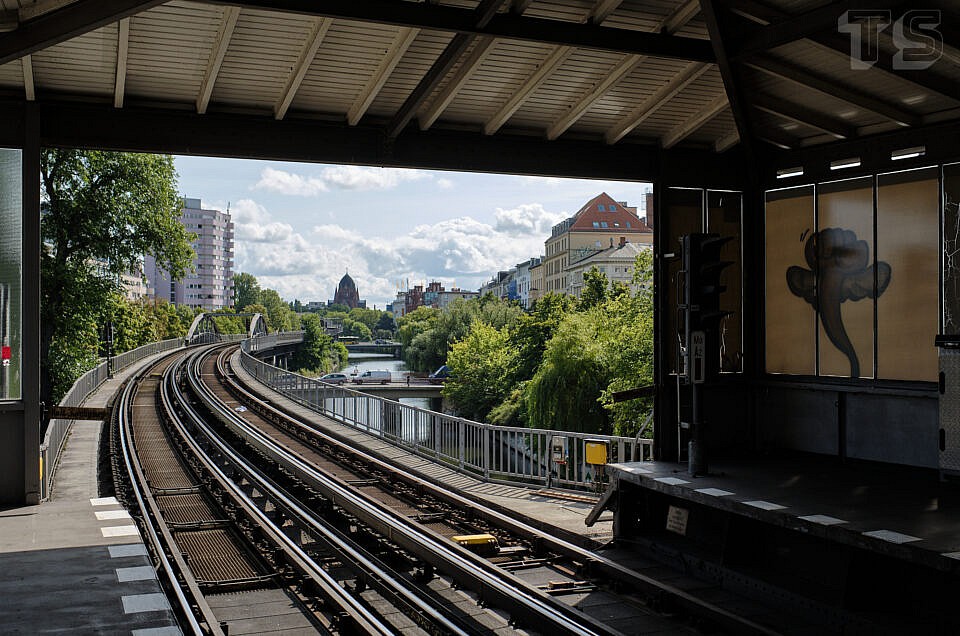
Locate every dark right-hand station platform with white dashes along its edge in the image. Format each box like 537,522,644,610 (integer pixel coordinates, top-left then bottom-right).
600,453,960,634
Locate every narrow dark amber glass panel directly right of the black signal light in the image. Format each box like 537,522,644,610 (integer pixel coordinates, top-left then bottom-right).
707,191,743,373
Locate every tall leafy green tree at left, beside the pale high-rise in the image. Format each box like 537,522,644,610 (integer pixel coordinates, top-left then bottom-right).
40,149,193,404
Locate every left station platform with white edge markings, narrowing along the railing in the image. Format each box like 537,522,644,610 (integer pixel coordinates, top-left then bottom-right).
0,358,181,636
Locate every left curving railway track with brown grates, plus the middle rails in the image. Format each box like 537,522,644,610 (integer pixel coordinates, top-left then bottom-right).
119,346,632,634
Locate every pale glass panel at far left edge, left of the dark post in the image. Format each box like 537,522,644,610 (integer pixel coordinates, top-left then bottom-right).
0,148,23,400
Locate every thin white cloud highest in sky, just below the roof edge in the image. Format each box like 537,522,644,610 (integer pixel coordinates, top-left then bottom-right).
253,166,436,197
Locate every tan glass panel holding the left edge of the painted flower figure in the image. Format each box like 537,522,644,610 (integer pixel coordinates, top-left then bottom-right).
764,186,817,375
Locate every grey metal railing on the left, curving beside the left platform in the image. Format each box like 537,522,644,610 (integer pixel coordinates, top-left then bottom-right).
40,338,183,501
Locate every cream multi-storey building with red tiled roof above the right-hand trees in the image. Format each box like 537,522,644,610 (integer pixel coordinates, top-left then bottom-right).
541,192,653,294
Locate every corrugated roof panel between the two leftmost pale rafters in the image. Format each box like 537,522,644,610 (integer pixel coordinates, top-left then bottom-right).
33,24,117,95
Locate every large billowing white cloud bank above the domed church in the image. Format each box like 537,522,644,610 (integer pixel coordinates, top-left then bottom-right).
234,200,565,307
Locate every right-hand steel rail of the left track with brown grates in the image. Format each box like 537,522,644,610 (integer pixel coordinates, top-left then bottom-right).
161,347,394,636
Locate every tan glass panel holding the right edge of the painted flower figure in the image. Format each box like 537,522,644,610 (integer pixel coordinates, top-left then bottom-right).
877,168,940,381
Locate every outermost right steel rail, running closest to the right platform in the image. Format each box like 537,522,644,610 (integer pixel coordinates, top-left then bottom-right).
222,353,779,636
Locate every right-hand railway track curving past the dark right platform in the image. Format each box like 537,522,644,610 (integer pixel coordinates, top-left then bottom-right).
195,354,788,633
